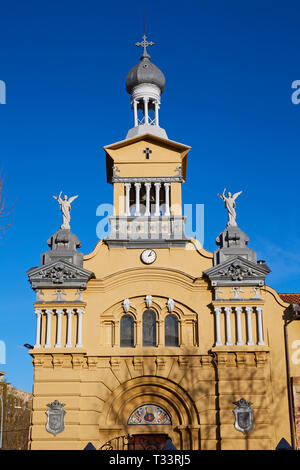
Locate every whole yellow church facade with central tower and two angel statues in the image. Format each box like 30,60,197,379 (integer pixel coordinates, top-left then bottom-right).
28,36,300,450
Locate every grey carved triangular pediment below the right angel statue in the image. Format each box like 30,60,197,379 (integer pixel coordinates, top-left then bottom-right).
203,256,271,286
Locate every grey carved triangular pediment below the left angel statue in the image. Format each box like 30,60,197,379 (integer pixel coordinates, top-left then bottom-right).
27,259,95,289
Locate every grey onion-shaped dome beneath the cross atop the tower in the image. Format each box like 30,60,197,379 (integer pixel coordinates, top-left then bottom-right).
126,54,165,94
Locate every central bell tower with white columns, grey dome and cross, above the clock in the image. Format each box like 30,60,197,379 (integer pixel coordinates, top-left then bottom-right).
104,35,190,248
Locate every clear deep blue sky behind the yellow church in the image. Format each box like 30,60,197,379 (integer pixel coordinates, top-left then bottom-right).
0,0,300,391
